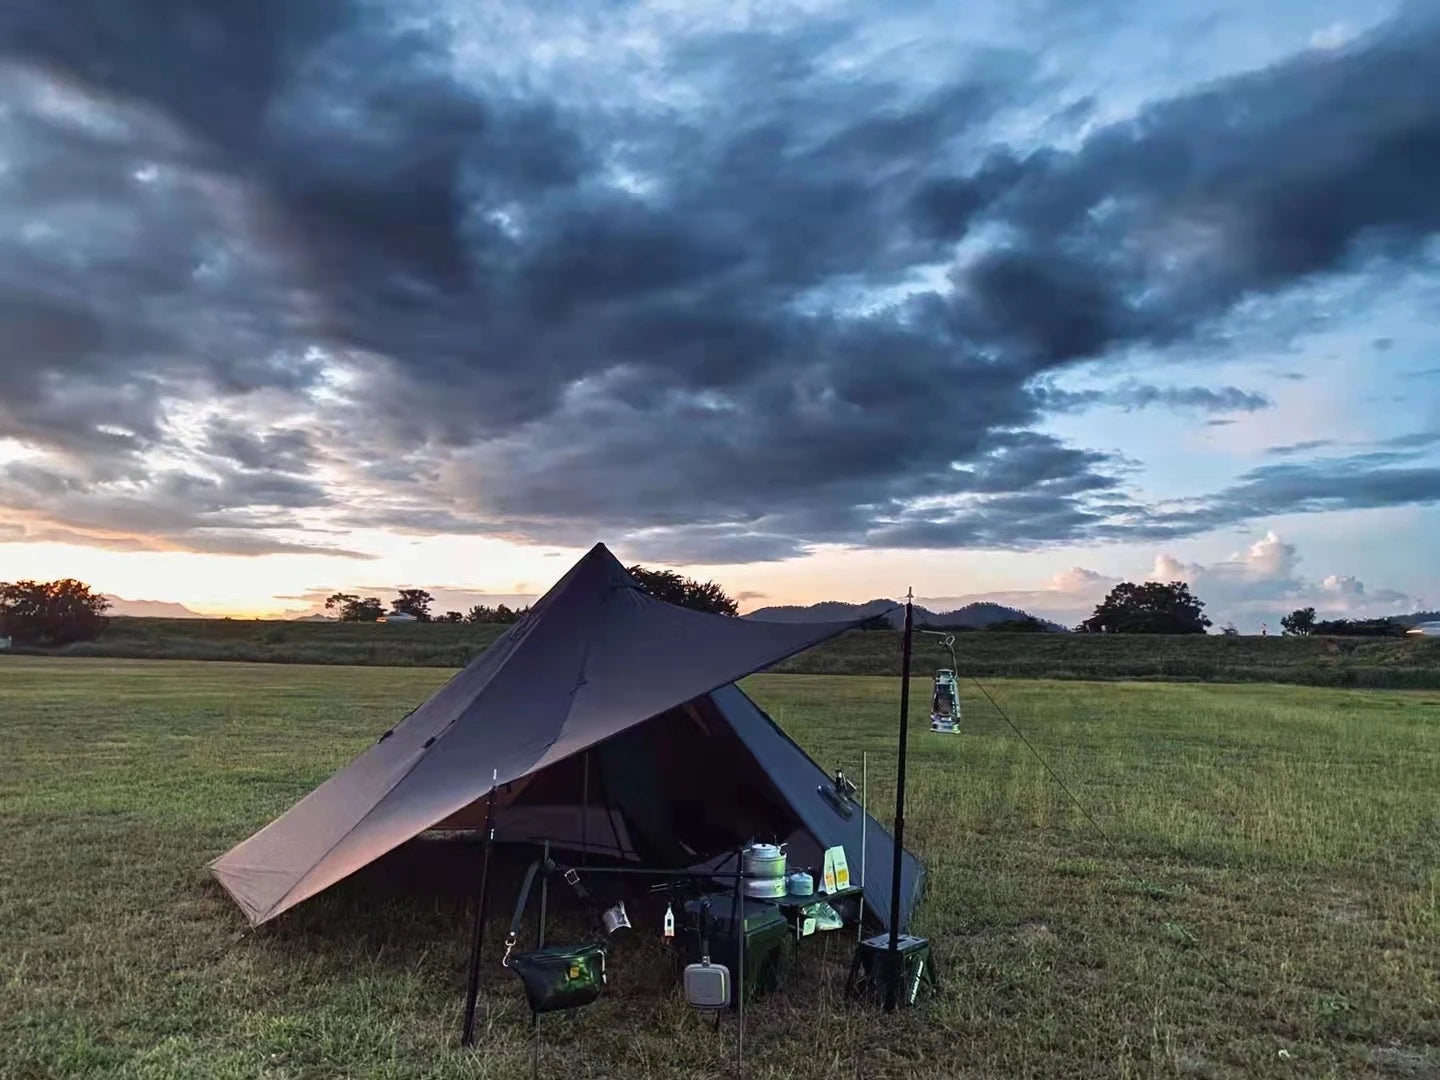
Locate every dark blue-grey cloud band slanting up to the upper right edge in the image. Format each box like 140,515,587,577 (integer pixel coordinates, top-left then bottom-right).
933,9,1440,364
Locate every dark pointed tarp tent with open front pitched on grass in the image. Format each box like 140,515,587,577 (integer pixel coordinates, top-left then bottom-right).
210,544,924,924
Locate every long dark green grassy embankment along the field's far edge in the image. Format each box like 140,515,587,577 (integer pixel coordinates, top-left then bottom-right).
19,618,1440,690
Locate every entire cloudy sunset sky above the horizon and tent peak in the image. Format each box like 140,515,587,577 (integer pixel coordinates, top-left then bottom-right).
0,0,1440,632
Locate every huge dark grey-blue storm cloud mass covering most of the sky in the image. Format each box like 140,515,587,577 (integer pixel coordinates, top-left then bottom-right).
0,0,1440,562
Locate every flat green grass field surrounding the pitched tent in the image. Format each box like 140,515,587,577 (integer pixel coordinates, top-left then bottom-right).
0,657,1440,1080
